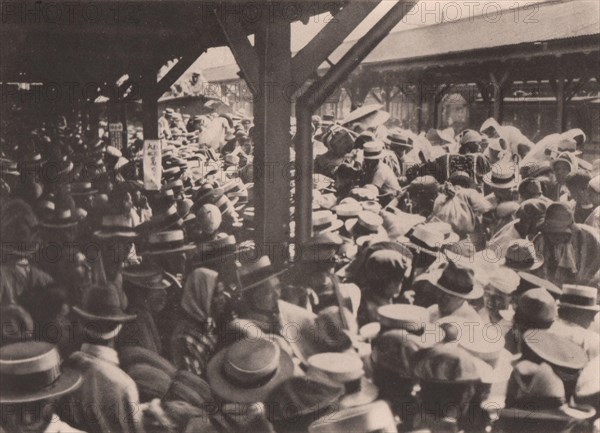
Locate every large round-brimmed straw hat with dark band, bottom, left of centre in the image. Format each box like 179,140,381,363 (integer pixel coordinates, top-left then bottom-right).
206,338,294,403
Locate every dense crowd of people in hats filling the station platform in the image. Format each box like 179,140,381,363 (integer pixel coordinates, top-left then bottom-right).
0,102,600,433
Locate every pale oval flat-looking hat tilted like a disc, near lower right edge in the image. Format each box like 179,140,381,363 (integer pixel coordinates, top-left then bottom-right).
523,329,588,370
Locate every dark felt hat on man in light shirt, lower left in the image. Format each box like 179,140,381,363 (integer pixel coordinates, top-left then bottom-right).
73,284,137,324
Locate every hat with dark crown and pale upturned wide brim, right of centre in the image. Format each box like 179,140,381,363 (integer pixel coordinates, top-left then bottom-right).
415,261,483,299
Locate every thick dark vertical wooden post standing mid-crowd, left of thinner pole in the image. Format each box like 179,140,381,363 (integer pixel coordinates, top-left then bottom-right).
254,17,292,265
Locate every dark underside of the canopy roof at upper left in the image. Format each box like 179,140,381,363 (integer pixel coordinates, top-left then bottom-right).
0,0,344,83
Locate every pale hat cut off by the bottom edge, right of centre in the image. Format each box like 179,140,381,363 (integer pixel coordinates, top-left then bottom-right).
308,400,397,433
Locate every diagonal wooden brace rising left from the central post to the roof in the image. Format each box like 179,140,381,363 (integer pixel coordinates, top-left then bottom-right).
213,9,259,95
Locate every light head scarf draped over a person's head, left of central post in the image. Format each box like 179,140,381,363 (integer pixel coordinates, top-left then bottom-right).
181,268,219,322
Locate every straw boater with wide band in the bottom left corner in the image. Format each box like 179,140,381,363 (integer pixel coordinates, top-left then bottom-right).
0,341,82,404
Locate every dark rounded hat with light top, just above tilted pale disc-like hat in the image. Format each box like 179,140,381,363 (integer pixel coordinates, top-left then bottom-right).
514,288,556,329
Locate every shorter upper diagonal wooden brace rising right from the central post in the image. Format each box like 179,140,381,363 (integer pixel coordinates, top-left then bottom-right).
292,0,381,86
